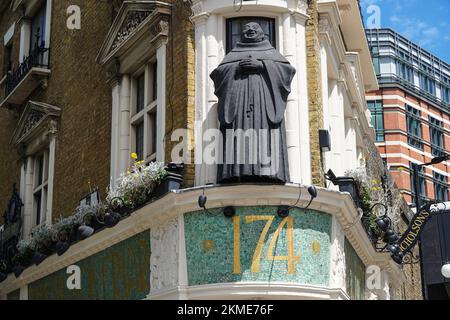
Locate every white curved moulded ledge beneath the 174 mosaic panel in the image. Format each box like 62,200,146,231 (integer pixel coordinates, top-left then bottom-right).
148,282,350,300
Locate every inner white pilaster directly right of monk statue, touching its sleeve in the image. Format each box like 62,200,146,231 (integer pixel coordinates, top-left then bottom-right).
282,13,302,183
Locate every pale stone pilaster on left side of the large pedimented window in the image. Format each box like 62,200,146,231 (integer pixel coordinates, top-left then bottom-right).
118,74,131,173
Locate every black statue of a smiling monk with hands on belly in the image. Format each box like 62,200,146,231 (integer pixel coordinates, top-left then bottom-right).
211,22,295,183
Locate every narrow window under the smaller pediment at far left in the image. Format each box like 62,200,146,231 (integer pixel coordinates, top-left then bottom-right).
33,149,49,227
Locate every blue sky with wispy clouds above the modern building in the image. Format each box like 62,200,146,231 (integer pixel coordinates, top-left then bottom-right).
361,0,450,63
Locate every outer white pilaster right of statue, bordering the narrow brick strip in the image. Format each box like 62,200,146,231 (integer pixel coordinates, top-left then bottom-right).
294,12,311,184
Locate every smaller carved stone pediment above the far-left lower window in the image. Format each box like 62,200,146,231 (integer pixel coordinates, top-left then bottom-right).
12,101,61,154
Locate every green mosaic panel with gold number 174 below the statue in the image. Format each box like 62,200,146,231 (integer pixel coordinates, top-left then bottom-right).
185,207,331,286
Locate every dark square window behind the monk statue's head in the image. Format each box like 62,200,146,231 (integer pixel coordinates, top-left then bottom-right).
227,17,276,53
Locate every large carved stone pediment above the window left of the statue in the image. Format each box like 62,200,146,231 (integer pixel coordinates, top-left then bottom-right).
97,1,171,71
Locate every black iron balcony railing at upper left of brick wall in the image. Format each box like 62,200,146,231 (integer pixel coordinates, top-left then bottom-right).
5,44,50,97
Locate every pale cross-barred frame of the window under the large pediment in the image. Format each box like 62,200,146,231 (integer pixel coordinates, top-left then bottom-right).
130,59,160,163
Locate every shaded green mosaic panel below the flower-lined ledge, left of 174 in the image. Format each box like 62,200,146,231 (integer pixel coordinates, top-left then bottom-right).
28,230,150,300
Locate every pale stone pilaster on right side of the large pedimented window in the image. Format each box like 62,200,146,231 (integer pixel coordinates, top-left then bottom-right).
156,40,167,162
